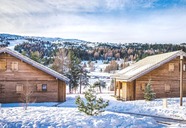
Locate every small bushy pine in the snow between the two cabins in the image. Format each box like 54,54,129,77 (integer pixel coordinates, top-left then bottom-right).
76,87,109,116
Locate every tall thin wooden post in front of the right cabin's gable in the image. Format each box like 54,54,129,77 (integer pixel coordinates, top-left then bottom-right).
180,55,183,106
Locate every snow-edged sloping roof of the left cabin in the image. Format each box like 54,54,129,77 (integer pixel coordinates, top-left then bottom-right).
0,48,69,82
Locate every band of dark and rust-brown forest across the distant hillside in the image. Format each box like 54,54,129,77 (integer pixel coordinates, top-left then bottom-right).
15,41,186,65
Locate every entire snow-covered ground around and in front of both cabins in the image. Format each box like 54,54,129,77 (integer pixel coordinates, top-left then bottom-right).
0,93,186,128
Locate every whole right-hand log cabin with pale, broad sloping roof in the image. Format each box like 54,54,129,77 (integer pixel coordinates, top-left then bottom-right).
112,51,186,101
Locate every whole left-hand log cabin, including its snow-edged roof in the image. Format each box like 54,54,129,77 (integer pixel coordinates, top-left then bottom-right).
0,48,69,103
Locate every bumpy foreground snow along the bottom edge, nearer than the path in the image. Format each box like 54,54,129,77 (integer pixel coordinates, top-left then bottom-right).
0,107,160,128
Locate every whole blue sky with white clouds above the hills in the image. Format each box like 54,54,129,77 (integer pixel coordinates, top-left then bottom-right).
0,0,186,43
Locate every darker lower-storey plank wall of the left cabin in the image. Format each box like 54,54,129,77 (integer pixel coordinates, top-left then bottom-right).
0,80,58,103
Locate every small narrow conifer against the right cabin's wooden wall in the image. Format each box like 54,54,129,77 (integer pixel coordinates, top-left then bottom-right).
144,80,156,101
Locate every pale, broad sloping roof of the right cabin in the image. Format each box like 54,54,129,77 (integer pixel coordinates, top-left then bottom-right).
113,51,186,82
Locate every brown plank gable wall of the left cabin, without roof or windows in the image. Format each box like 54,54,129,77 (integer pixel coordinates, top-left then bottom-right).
0,53,66,102
